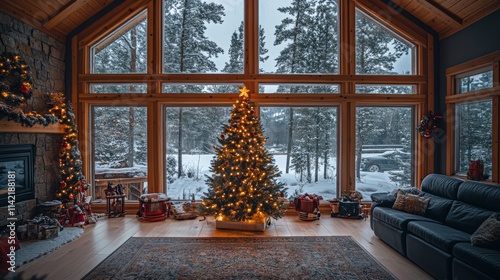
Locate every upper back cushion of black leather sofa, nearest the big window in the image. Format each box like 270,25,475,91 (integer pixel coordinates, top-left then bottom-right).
421,174,464,200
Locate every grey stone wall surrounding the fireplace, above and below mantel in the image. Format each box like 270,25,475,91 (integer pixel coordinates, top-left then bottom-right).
0,11,66,226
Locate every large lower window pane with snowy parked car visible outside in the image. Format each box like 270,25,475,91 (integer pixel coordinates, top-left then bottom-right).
356,107,414,199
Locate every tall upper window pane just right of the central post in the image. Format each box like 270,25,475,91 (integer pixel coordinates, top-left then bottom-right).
259,0,340,74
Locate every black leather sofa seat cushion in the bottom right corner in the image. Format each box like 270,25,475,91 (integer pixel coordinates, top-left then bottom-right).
453,243,500,278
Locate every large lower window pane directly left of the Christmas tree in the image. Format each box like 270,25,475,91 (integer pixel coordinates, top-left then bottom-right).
165,107,231,200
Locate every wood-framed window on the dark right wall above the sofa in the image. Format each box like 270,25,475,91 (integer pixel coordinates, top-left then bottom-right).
446,51,500,183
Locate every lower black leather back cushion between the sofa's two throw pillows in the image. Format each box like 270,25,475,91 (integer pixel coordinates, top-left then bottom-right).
445,201,493,234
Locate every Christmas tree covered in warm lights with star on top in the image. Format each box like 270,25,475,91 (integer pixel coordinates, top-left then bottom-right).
200,87,285,222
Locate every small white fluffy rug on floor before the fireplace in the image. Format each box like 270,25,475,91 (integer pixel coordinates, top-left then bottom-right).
16,227,83,267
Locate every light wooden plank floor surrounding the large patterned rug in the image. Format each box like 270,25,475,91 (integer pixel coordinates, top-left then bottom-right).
11,211,432,280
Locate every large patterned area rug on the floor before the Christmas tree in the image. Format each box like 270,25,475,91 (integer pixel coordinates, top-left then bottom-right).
83,236,396,280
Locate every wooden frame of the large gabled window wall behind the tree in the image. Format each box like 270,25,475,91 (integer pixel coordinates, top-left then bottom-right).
71,0,435,206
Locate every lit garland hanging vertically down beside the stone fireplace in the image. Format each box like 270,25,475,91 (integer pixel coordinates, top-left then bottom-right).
49,93,88,203
